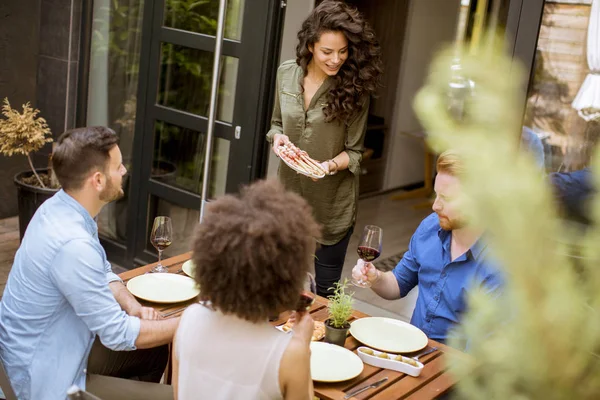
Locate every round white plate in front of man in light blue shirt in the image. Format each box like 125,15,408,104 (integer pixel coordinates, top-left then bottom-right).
127,273,200,303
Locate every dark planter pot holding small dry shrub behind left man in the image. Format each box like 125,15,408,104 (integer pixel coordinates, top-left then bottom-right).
14,168,60,240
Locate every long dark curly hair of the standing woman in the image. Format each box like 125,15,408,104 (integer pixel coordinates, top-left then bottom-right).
296,0,383,125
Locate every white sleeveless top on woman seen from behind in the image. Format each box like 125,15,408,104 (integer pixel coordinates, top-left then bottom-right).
175,304,292,400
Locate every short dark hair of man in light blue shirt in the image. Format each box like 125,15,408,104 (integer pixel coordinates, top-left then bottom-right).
52,126,119,190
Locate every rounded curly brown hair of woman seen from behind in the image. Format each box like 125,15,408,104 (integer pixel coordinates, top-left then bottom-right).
192,181,320,322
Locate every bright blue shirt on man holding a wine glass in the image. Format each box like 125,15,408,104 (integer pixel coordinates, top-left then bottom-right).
393,213,502,342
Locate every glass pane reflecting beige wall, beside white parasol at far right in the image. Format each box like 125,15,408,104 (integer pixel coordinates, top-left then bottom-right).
523,1,600,172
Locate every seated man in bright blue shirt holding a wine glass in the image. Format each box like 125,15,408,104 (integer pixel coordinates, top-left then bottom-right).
352,151,502,344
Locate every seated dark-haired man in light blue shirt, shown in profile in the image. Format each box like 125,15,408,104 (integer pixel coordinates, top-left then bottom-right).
0,127,179,400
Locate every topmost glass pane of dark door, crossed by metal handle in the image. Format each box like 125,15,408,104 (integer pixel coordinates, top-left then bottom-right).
163,0,244,40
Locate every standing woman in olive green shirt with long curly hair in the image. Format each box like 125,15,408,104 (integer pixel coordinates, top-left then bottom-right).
267,0,382,296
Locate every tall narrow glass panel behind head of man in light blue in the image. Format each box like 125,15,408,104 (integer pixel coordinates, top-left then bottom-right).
86,0,144,241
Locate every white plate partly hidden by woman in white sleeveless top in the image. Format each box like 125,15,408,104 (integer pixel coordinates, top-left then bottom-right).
310,342,364,382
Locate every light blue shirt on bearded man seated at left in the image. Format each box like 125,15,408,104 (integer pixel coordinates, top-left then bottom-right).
0,190,140,400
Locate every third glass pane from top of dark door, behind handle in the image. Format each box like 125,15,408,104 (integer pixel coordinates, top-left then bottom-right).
152,121,229,198
